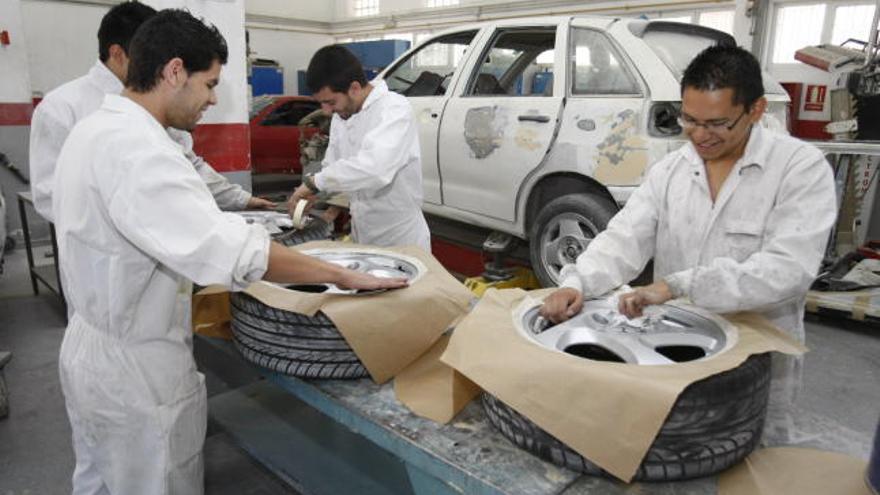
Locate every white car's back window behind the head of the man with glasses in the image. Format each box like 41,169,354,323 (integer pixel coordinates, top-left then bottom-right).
630,21,787,95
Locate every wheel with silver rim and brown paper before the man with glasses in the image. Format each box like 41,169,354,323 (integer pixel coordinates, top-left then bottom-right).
482,301,770,481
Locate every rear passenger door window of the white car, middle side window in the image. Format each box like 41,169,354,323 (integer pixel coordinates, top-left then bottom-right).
467,26,556,96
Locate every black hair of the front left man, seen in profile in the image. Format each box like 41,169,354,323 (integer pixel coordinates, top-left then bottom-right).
125,9,229,93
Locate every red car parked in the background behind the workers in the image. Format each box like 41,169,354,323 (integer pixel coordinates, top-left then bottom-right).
250,95,321,174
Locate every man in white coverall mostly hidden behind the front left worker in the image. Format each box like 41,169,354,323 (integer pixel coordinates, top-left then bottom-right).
30,2,275,222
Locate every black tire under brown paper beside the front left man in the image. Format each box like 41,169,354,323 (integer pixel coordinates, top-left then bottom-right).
230,292,367,379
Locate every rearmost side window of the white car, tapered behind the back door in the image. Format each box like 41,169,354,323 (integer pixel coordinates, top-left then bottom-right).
571,28,640,95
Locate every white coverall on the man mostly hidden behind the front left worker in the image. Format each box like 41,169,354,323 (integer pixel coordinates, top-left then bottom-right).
30,60,251,222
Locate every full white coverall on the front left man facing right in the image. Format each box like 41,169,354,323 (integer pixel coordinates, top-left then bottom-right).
53,95,269,495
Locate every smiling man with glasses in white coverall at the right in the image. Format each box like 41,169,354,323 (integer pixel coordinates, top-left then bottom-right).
542,46,836,444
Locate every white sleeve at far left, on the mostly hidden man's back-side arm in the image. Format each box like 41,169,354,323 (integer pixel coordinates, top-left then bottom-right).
28,100,76,222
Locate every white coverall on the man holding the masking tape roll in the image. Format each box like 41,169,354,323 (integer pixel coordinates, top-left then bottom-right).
314,81,431,252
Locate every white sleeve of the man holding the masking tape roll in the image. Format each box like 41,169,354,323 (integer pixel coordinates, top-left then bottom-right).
315,102,418,193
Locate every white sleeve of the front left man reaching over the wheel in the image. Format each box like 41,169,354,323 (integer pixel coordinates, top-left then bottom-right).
102,145,270,290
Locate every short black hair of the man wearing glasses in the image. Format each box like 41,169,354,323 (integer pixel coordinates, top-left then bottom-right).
681,44,764,109
